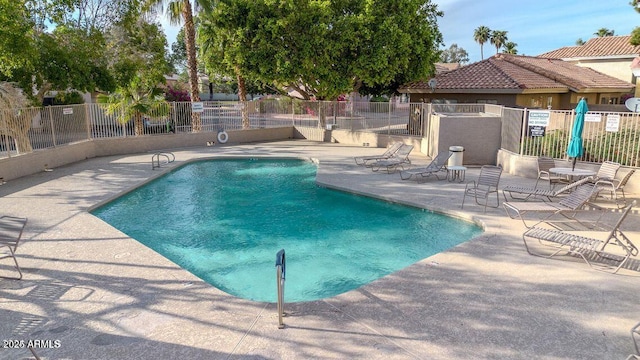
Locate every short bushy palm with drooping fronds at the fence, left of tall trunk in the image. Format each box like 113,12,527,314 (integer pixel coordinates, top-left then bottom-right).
98,75,169,136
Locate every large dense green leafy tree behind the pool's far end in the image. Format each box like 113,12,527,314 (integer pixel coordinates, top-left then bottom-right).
200,0,442,100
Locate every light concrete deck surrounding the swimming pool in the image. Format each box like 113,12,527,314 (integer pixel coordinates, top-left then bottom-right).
0,141,640,360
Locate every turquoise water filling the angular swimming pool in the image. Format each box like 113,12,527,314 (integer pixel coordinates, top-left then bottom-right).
93,159,482,302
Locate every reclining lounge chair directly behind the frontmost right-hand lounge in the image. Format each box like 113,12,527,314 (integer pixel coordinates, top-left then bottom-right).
503,182,596,228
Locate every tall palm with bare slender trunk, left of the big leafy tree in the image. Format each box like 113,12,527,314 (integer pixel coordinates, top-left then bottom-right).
146,0,214,132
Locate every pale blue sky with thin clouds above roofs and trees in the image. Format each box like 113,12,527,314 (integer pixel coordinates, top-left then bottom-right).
160,0,640,63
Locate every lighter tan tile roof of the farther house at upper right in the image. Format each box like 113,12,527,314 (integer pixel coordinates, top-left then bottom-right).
538,35,640,59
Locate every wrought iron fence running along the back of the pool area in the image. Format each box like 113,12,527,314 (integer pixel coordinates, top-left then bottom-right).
0,98,640,167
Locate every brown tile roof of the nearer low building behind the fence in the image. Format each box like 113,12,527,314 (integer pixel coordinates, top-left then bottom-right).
400,54,634,94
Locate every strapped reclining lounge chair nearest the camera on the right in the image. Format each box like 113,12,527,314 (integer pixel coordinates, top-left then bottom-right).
522,201,638,273
